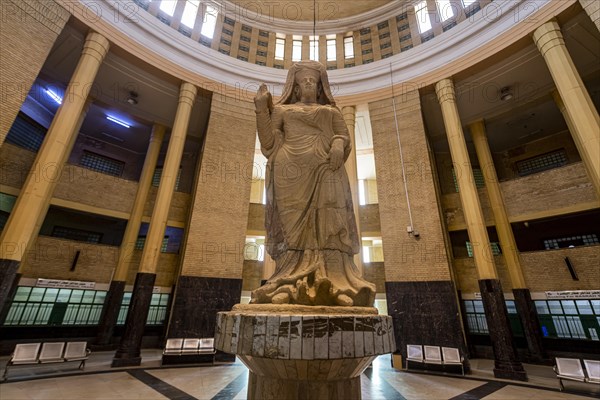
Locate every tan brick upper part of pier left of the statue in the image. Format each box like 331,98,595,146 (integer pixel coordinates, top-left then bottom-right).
181,95,256,279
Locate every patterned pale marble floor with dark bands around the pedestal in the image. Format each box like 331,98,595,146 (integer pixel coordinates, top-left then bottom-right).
0,350,600,400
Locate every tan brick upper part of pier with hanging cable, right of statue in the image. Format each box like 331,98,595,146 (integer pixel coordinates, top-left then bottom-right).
369,91,450,281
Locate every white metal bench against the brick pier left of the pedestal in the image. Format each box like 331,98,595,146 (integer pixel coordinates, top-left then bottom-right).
162,338,216,364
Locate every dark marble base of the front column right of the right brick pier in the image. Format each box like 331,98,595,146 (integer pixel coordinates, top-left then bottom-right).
479,279,527,381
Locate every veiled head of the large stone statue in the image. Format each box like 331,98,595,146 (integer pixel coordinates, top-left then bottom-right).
277,61,335,106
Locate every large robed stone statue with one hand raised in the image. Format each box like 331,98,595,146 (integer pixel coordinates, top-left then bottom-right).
251,61,375,307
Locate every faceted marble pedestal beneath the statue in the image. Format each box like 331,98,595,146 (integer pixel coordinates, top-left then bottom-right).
215,304,396,400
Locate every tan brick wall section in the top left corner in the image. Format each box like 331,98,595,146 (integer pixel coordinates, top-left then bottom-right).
0,0,70,145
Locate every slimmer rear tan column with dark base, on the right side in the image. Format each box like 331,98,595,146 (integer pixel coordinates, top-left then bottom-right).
469,120,544,361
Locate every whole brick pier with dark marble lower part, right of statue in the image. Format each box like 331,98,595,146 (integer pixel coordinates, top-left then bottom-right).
369,89,468,369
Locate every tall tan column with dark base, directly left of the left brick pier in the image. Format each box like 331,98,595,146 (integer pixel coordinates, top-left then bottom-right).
112,82,198,367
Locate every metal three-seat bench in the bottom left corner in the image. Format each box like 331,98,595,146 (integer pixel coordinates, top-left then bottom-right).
2,342,90,380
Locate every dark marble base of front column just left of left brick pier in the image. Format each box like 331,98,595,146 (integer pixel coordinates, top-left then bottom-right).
111,272,156,367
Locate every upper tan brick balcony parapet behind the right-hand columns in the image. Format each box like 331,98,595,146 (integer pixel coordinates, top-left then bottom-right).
442,162,598,230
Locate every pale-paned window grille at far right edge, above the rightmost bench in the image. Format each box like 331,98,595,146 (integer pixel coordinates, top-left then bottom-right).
534,299,600,340
